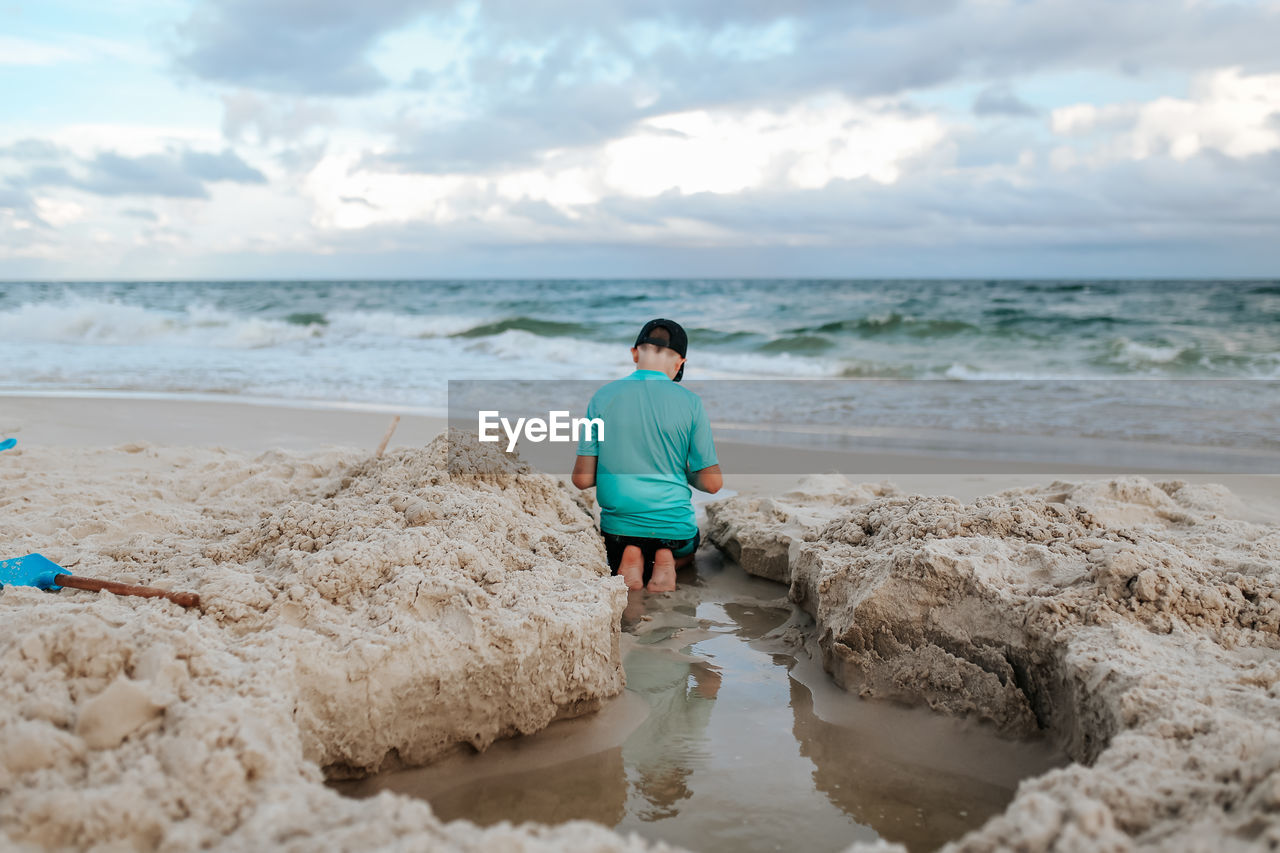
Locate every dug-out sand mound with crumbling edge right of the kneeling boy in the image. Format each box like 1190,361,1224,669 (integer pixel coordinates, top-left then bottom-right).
708,478,1280,850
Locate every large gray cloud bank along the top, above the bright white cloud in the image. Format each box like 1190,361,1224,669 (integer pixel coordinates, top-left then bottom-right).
366,0,1280,172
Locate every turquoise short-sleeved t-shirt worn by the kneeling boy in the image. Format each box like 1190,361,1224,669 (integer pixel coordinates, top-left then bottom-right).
577,370,717,539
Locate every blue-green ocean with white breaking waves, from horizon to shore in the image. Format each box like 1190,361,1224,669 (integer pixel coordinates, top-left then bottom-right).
0,279,1280,466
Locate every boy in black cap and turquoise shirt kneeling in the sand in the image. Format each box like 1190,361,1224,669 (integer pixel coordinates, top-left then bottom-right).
573,319,723,592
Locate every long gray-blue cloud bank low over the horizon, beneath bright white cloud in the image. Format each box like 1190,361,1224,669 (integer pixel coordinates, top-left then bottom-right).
296,140,1280,275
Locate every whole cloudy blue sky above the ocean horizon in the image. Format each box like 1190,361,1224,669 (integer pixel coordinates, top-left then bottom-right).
0,0,1280,279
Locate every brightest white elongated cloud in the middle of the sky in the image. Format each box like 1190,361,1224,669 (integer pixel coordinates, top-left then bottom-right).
303,96,945,228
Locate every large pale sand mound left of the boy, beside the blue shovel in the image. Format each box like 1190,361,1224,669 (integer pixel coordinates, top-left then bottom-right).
0,438,660,850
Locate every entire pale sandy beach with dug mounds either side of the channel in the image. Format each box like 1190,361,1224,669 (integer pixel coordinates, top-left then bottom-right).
0,397,1280,850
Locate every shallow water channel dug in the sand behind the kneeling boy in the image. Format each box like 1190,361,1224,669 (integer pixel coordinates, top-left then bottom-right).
334,548,1065,852
